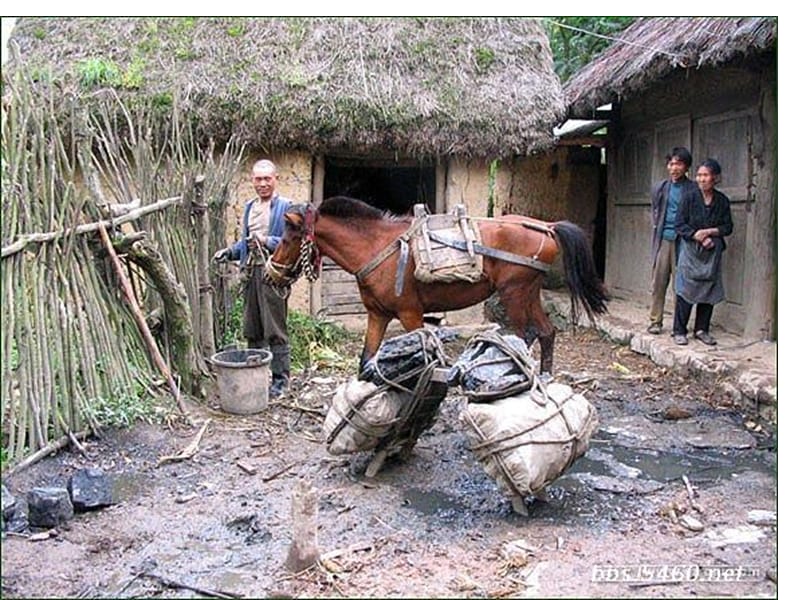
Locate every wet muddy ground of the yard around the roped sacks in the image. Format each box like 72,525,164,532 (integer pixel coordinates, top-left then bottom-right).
2,330,777,598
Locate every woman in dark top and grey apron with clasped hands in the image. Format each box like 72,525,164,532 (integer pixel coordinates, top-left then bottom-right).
672,158,733,346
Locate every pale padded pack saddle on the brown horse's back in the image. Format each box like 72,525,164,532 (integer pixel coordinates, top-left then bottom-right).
408,204,483,283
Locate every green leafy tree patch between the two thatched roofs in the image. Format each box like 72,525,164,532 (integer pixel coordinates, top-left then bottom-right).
542,17,635,83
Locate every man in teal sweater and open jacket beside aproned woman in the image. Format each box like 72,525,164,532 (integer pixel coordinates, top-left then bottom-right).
647,147,697,334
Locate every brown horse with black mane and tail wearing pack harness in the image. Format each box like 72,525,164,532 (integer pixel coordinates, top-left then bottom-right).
266,196,608,375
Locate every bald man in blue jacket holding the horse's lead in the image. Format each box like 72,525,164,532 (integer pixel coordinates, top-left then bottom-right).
214,160,292,398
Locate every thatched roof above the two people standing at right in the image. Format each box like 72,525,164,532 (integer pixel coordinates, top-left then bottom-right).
564,17,778,116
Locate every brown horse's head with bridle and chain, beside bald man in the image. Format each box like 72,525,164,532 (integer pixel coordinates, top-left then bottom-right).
265,204,321,287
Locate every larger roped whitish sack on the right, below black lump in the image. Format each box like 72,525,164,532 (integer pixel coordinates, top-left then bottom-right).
460,383,598,496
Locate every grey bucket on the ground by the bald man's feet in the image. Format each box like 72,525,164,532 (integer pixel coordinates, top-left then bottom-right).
211,348,272,415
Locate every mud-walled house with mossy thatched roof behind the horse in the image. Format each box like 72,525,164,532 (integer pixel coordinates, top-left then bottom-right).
3,17,566,326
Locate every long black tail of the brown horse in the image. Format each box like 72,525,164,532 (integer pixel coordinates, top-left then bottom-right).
553,221,610,324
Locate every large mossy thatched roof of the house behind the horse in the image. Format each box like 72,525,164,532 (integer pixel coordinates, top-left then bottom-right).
3,17,565,157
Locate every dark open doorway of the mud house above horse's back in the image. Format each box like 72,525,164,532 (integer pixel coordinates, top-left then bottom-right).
323,157,436,215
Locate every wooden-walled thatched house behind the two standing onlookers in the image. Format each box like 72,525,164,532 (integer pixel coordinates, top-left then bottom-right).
565,17,778,339
